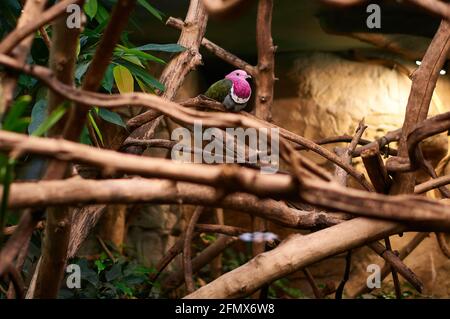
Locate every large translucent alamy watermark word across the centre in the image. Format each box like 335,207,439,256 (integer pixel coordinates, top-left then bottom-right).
171,121,279,174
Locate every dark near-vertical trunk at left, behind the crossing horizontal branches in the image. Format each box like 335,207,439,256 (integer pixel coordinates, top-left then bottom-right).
33,6,83,299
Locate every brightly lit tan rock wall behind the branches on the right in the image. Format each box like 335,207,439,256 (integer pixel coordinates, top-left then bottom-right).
273,53,450,297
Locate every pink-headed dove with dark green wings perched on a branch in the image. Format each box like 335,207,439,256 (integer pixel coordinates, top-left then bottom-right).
205,70,252,112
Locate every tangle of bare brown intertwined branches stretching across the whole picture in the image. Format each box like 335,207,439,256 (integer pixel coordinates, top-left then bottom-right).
0,0,450,298
